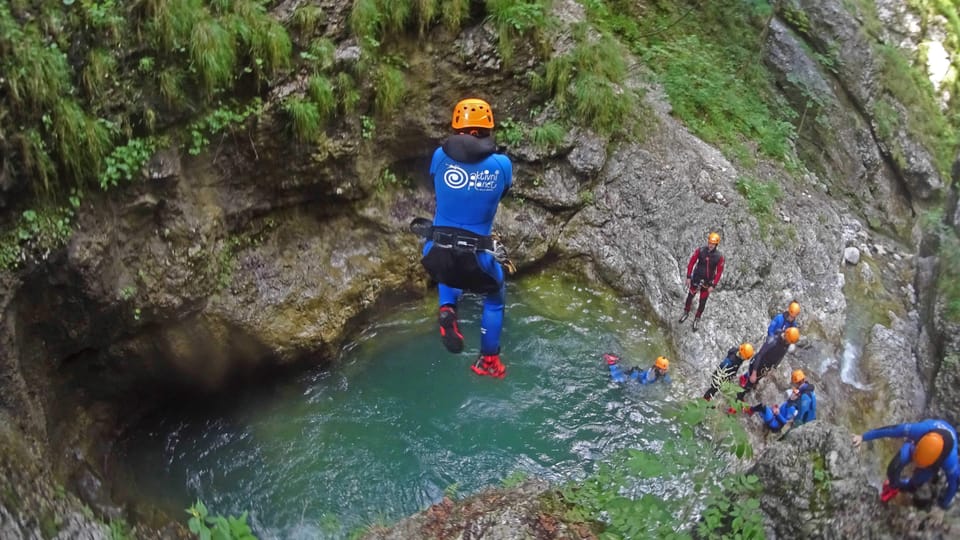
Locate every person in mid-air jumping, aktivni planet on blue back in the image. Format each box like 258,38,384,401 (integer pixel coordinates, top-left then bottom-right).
421,98,513,378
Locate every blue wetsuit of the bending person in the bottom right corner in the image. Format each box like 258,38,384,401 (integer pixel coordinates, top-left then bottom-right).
863,419,960,510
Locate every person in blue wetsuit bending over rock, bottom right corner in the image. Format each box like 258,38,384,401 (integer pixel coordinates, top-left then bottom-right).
853,419,960,525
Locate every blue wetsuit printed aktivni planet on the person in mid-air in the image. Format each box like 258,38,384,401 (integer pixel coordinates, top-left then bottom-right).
423,134,513,355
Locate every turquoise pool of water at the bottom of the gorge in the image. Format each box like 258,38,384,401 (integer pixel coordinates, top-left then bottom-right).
119,275,676,539
